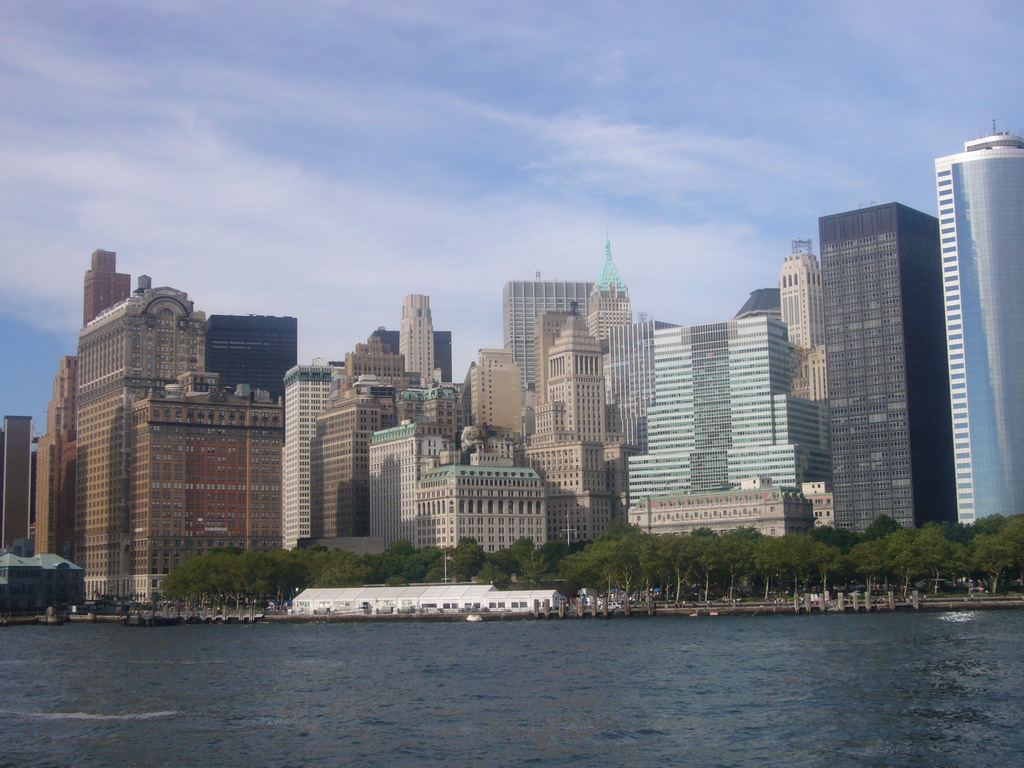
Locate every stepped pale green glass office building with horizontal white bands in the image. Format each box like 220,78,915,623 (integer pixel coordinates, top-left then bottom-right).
630,316,830,504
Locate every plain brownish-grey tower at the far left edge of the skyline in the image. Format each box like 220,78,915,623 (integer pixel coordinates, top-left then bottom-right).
0,416,33,549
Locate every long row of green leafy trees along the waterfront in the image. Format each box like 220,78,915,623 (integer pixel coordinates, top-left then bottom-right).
162,515,1024,604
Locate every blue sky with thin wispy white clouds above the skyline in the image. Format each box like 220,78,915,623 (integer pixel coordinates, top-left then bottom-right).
0,0,1024,433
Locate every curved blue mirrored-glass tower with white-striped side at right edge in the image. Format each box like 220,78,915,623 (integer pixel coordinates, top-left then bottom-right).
935,133,1024,522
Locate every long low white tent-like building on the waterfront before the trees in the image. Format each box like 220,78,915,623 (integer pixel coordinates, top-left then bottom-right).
292,584,564,615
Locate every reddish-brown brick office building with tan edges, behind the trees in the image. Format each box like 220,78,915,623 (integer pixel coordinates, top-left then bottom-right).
129,371,285,597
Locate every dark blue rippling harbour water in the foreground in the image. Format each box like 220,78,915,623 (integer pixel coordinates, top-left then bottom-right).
0,611,1024,768
